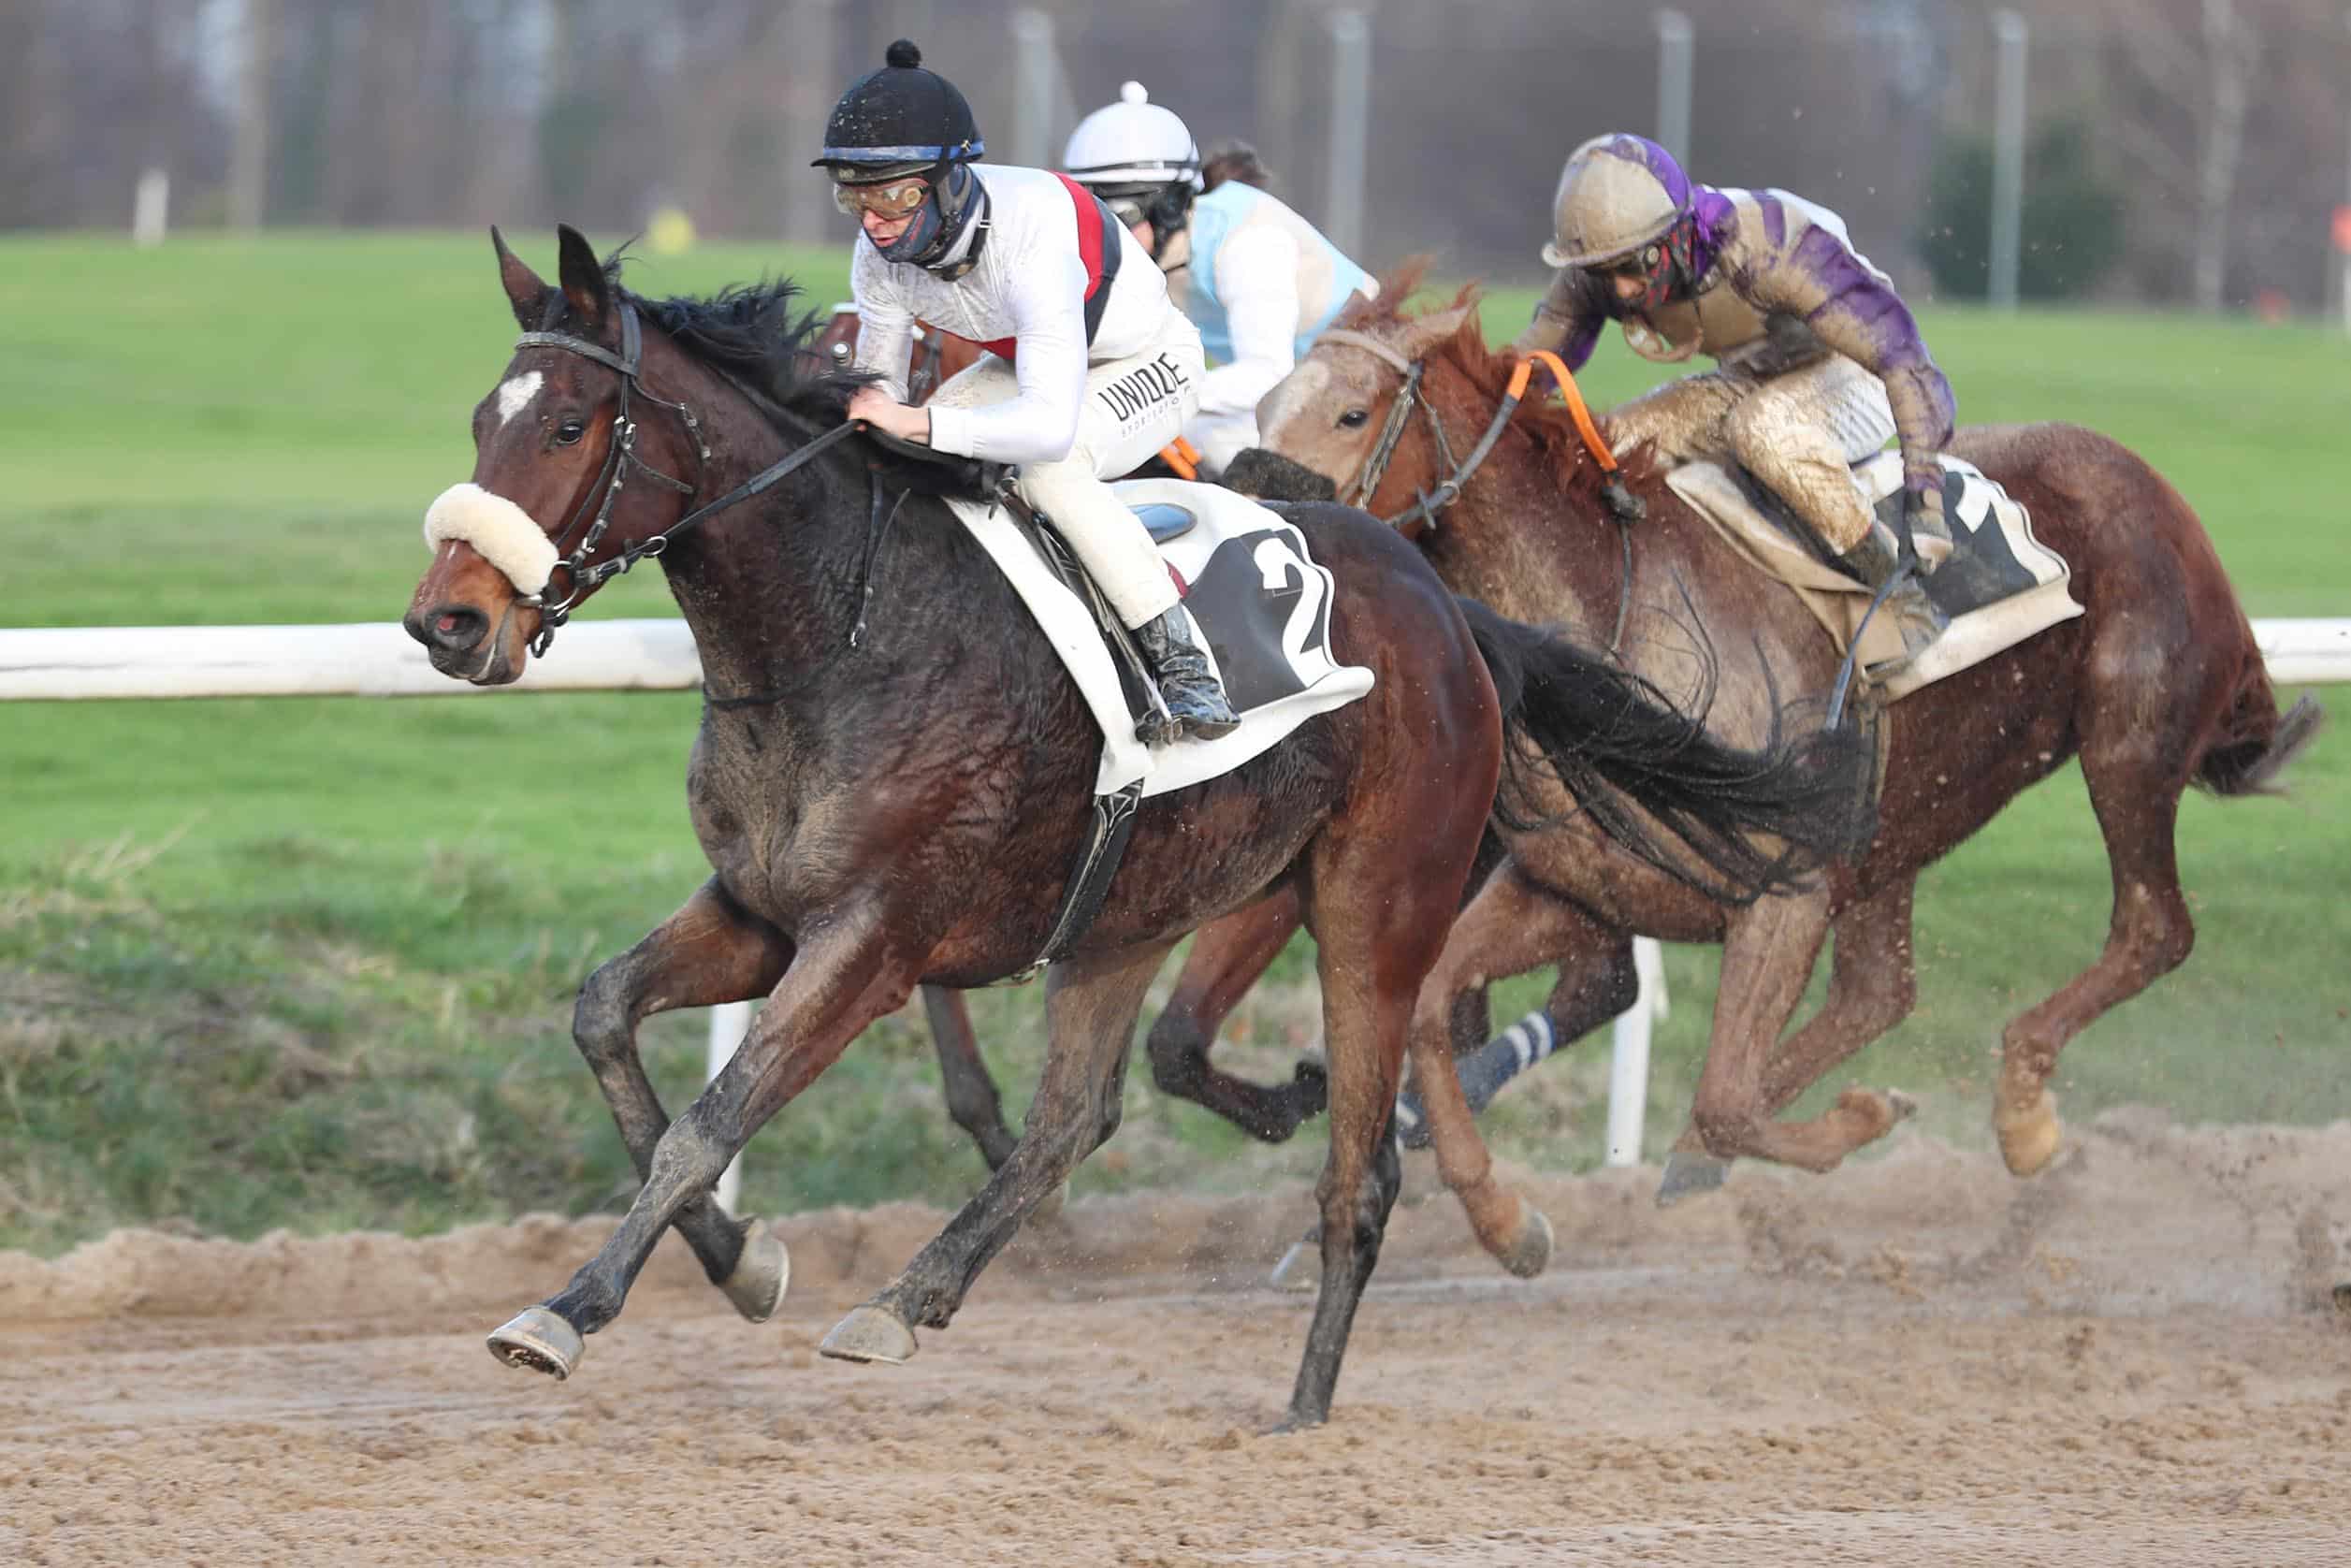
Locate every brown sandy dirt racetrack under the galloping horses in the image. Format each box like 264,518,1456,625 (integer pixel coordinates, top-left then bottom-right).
0,1112,2351,1568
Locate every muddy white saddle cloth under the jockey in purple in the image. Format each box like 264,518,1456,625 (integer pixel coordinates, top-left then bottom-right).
1664,451,2083,701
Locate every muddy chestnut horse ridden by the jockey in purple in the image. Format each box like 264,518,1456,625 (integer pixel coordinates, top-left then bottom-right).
1183,268,2323,1201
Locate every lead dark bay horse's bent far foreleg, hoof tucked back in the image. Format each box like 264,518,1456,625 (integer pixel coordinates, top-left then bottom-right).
572,879,792,1324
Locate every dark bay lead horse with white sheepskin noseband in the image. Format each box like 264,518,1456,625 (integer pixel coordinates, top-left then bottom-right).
404,228,1866,1427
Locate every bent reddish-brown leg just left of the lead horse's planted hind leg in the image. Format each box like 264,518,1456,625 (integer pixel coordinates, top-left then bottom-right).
1147,889,1324,1142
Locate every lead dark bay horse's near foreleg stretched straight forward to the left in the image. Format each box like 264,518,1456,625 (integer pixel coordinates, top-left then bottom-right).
489,909,924,1377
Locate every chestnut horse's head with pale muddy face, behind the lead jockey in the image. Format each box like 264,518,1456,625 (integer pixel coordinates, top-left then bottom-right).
1227,270,1484,533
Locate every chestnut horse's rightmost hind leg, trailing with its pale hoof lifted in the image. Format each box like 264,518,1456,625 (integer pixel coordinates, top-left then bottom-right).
1992,748,2196,1175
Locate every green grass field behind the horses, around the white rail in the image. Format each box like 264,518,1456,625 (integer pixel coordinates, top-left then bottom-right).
0,233,2351,1248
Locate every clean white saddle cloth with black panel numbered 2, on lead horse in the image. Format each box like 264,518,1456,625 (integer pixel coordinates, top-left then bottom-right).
948,480,1373,797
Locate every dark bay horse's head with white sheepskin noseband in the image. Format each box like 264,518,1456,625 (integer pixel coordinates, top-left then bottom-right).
402,225,710,687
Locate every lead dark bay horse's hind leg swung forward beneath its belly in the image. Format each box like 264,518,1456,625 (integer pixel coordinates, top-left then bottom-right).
819,940,1176,1363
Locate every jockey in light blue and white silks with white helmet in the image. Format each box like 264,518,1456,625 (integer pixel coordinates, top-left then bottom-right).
1063,82,1380,477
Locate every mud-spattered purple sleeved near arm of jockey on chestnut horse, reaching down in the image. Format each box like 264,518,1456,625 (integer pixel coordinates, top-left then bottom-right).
1747,225,1956,489
